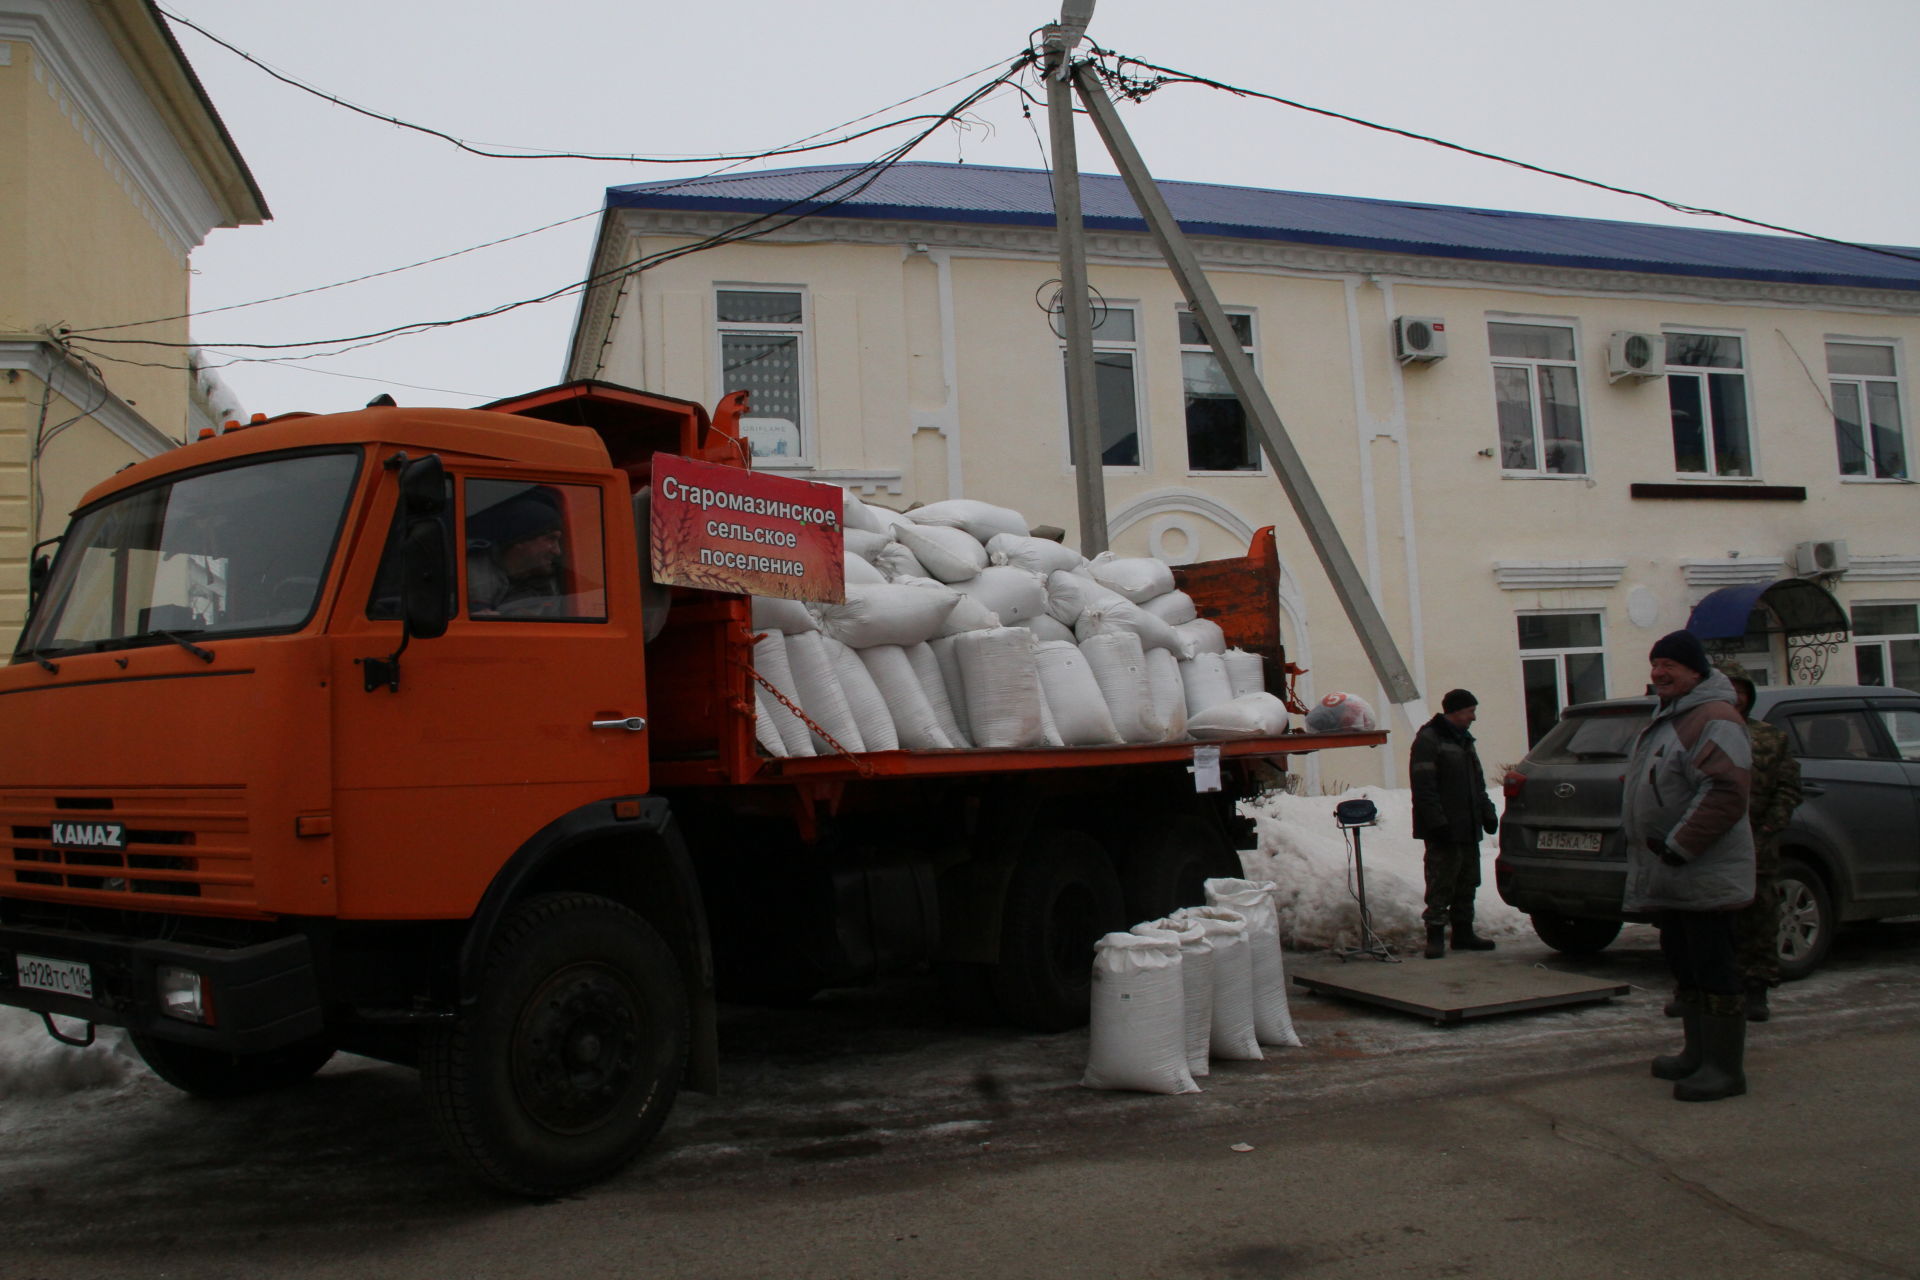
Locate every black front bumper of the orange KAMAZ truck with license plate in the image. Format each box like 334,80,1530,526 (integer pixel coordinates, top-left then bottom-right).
0,925,324,1054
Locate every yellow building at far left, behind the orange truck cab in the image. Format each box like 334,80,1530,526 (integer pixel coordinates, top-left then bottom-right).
0,0,267,649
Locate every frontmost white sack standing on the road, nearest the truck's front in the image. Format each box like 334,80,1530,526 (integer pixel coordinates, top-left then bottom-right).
1081,933,1200,1094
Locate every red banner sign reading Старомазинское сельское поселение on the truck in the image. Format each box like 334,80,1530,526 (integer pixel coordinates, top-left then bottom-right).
651,453,847,601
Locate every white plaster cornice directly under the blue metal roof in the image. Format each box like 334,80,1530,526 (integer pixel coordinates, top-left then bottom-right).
620,209,1920,315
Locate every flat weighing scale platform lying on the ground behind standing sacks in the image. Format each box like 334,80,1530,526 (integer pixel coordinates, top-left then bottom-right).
1286,952,1632,1027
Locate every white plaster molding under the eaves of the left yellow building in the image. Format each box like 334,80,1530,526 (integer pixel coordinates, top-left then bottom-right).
0,0,225,263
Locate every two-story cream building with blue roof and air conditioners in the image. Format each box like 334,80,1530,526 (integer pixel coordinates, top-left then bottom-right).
568,163,1920,783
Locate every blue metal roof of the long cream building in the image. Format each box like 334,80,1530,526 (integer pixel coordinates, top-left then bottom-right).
607,161,1920,290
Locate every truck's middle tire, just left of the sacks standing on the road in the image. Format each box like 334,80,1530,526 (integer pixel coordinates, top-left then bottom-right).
993,831,1127,1031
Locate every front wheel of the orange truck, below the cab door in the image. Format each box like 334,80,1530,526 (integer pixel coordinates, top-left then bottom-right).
420,892,689,1196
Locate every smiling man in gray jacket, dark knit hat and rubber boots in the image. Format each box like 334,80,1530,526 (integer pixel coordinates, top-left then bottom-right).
1620,631,1753,1102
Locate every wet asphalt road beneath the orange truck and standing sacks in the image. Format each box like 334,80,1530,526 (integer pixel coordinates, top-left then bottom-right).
0,925,1920,1280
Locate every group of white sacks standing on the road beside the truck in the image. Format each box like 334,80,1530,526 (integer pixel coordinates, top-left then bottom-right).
1081,879,1300,1094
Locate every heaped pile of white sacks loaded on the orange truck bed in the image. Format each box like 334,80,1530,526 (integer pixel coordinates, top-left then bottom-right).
753,493,1286,756
